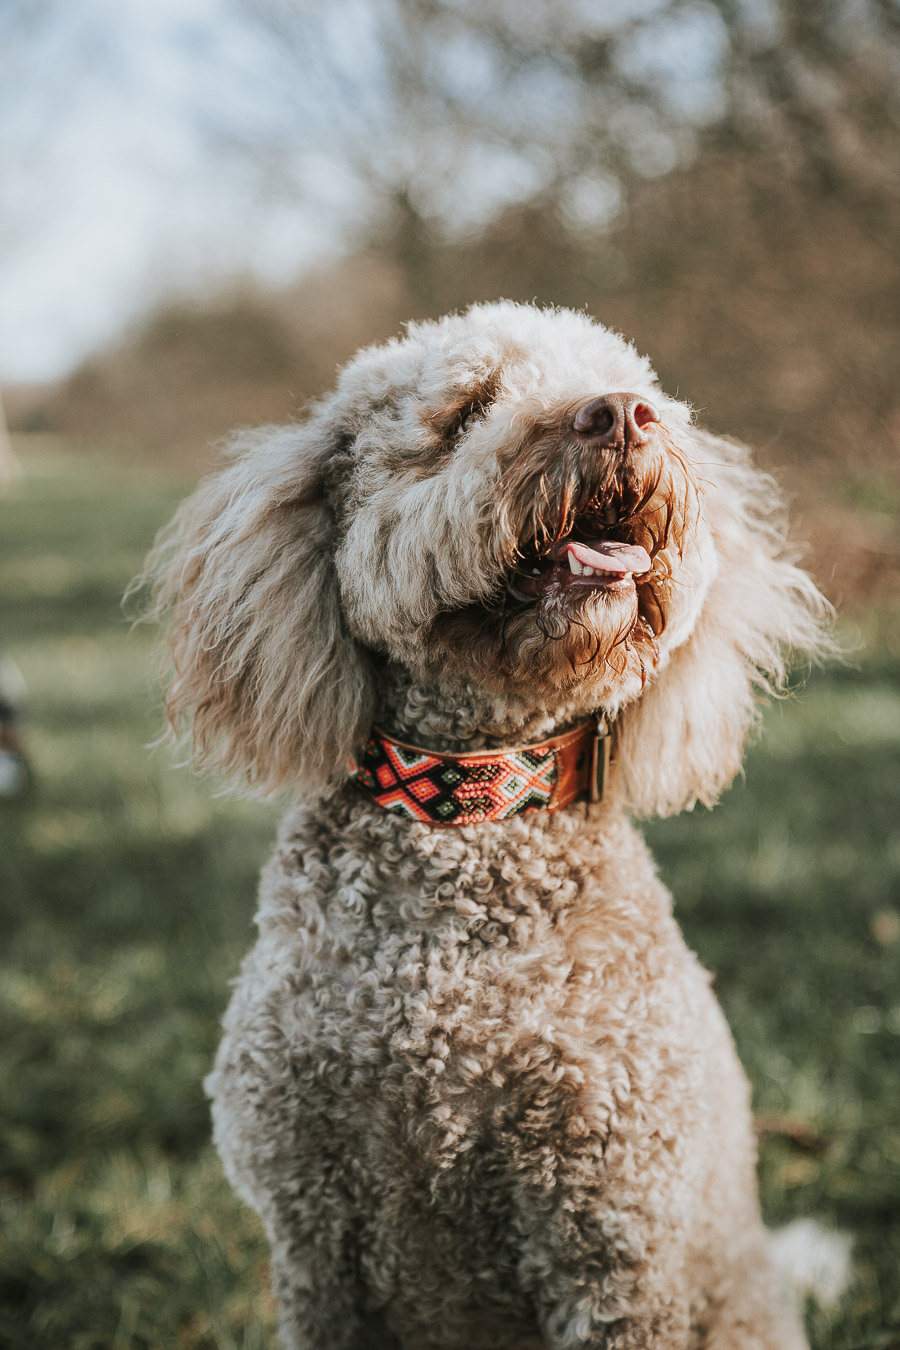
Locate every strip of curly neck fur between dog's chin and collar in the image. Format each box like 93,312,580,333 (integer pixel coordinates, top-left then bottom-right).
375,662,601,753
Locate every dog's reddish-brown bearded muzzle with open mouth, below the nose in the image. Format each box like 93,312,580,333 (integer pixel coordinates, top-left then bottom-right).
434,433,698,689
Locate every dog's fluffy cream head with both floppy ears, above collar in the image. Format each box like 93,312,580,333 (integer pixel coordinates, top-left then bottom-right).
150,304,823,813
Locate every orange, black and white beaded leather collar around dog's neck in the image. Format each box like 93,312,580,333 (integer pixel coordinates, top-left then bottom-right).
352,714,610,825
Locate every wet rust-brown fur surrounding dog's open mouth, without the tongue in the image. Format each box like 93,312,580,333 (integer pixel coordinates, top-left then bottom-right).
434,409,699,676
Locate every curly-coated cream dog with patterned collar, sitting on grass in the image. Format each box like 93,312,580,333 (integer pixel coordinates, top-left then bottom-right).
151,302,826,1350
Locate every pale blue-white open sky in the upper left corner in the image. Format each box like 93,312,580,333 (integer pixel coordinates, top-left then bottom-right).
0,0,341,382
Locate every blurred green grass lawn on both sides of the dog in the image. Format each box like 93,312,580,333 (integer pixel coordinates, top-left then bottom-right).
0,446,900,1350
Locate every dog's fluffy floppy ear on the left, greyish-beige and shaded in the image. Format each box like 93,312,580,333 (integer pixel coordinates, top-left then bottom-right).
143,416,371,795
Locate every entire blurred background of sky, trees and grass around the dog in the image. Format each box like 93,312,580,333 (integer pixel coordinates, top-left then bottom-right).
0,0,900,1350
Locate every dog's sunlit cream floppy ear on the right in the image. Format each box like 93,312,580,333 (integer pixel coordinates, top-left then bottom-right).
617,432,834,815
